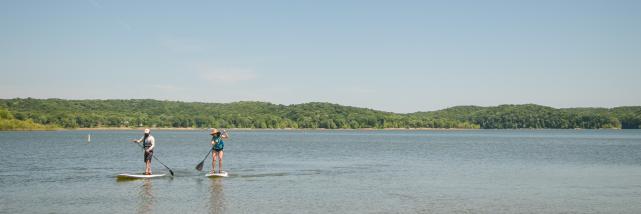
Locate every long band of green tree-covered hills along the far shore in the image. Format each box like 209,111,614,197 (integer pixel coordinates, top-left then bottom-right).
0,98,641,130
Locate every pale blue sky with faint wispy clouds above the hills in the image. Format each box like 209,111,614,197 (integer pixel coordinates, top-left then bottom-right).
0,0,641,112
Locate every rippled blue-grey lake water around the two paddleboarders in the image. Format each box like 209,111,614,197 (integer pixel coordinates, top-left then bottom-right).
0,130,641,213
